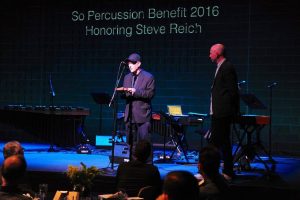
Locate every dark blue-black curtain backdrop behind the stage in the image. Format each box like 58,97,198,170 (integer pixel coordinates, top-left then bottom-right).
0,0,300,153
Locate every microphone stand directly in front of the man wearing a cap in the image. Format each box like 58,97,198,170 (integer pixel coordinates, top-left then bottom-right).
108,62,126,171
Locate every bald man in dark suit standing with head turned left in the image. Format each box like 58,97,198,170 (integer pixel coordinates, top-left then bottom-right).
209,44,240,180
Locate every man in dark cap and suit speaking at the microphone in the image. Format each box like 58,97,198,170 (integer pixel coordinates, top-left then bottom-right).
123,53,155,152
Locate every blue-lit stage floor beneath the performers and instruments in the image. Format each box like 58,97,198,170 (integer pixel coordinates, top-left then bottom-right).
0,143,300,199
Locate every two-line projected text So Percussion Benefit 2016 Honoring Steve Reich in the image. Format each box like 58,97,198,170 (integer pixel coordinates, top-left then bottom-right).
71,5,220,37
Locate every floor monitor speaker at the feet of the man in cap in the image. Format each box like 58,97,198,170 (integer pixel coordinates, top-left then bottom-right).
109,143,129,164
